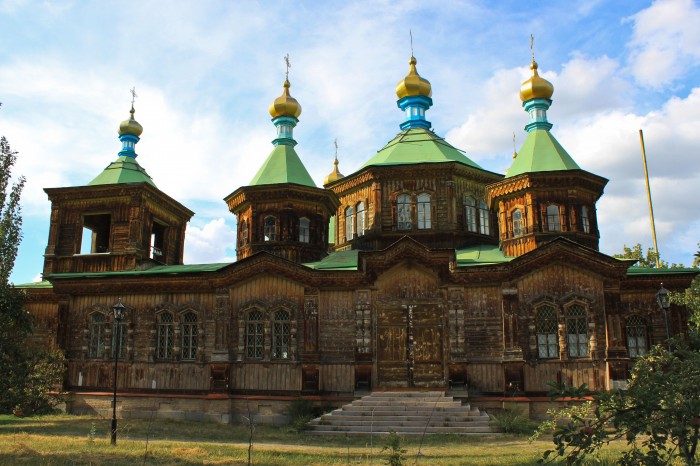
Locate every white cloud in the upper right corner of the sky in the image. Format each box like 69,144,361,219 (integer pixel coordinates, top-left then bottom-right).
628,0,700,88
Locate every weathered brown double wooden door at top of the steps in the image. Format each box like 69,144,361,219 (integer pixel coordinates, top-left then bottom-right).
377,305,445,387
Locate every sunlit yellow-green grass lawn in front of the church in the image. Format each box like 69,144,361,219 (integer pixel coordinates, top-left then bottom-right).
0,415,623,466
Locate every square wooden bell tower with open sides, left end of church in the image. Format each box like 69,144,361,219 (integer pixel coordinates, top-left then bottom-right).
43,94,194,276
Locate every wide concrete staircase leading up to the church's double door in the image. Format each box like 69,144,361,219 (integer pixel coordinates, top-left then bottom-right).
308,391,494,435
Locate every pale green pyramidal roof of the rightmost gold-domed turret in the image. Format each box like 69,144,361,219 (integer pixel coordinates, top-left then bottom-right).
506,129,581,178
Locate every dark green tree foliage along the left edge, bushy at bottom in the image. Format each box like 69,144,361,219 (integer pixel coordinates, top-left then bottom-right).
0,104,64,413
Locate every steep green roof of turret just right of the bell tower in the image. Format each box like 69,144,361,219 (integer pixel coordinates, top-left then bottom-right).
250,144,316,188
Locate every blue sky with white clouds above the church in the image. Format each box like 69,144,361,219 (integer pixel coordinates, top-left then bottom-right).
0,0,700,283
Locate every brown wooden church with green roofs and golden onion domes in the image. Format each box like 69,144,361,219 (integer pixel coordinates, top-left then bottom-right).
24,51,697,422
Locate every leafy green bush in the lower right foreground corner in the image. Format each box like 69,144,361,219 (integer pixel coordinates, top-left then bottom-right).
533,332,700,465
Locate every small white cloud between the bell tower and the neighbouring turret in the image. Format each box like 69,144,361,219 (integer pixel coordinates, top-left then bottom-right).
185,218,236,264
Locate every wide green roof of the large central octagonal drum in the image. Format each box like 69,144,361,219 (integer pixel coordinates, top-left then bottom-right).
360,128,481,169
